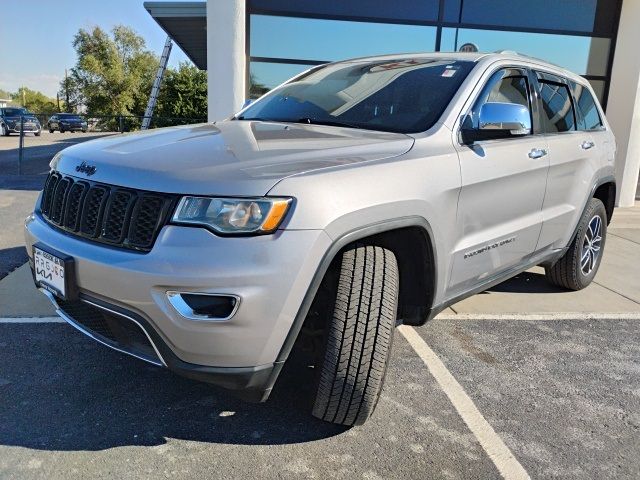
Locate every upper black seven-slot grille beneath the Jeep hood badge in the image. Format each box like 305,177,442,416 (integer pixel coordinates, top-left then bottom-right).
40,172,176,252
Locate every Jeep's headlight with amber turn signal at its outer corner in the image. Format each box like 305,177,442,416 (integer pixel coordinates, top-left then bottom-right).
172,197,291,234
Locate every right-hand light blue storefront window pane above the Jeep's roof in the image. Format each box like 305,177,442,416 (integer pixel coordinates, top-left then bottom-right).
441,28,611,76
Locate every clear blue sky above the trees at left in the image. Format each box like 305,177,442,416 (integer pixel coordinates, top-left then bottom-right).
0,0,189,98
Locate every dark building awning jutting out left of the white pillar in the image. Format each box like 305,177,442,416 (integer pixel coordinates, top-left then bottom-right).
144,2,207,70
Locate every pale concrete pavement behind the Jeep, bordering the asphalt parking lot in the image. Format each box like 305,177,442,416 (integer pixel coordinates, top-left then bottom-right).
0,203,640,318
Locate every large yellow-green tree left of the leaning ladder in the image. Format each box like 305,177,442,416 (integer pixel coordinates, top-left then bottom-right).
60,25,159,115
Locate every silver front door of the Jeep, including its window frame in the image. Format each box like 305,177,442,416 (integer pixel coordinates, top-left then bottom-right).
449,67,549,296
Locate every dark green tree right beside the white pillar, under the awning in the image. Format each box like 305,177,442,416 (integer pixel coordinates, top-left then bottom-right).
154,63,207,119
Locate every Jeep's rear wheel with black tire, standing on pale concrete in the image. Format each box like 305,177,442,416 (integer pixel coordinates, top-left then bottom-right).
545,198,607,290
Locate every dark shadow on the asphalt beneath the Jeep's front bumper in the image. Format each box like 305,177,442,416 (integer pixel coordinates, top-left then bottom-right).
0,324,346,451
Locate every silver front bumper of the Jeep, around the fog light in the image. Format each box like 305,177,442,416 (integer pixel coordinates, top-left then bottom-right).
25,214,331,398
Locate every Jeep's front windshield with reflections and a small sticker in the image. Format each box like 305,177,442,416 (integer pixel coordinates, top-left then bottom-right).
235,58,475,133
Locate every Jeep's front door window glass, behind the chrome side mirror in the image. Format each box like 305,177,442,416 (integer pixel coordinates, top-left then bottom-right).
463,70,531,133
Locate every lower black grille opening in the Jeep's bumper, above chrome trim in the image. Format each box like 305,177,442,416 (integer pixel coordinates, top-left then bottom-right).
56,299,161,364
